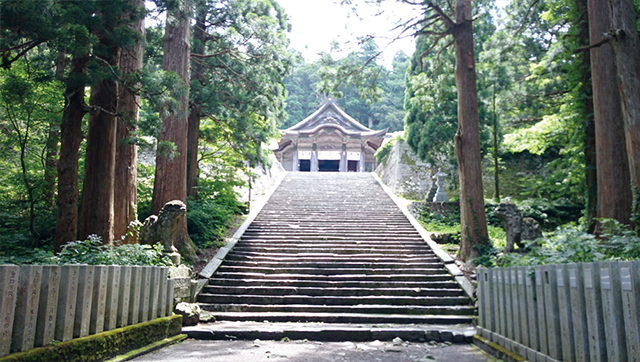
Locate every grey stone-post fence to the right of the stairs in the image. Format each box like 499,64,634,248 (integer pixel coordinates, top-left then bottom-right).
477,262,640,362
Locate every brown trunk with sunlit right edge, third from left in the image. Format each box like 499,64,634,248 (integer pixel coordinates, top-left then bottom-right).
113,0,145,244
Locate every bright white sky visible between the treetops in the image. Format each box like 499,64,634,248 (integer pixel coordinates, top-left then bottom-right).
277,0,508,69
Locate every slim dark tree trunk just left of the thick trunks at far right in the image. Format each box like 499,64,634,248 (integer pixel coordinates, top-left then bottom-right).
576,0,598,233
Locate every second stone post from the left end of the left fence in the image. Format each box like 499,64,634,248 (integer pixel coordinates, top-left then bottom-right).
11,265,42,352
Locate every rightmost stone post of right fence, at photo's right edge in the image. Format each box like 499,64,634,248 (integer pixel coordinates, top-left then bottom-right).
618,261,640,361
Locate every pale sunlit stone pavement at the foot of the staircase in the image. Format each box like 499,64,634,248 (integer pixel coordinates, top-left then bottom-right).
133,339,498,362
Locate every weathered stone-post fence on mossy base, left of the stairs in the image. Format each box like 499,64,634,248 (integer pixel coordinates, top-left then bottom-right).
0,264,173,357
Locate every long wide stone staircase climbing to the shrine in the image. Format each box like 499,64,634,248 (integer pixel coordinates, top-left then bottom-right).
198,173,474,325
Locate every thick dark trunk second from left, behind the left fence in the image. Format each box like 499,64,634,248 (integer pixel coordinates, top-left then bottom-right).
78,37,120,244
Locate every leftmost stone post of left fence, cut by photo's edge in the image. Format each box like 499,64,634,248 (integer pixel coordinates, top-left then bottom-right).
0,265,20,357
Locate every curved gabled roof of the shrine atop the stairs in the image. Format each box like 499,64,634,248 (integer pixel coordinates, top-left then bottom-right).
281,98,387,138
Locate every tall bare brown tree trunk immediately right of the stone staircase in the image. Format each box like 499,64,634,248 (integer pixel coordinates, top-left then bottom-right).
453,0,489,261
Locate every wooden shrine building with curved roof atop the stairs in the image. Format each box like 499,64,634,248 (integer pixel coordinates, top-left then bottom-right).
274,98,387,172
